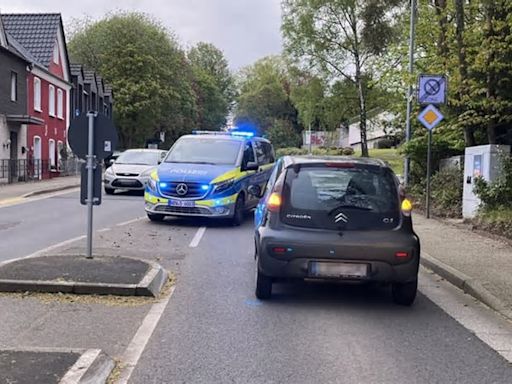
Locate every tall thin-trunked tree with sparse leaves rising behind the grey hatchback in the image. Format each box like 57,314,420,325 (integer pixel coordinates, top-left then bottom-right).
282,0,401,156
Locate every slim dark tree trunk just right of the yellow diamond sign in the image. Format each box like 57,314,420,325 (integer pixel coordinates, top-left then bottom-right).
454,0,476,147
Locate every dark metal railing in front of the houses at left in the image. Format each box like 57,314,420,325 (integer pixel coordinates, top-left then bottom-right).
0,158,81,184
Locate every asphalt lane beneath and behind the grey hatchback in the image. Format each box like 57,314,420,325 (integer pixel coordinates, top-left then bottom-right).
130,220,512,384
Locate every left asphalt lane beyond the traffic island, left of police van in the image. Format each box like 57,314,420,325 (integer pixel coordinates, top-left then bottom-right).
0,192,144,262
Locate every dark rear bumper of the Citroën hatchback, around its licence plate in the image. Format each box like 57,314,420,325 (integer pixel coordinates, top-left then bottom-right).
256,226,420,283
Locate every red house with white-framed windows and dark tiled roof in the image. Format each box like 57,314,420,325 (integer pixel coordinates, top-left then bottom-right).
1,14,72,177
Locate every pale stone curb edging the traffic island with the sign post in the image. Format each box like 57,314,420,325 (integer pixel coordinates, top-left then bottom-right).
0,258,169,297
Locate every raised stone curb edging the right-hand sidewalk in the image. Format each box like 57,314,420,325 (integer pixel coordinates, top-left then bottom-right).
421,252,512,320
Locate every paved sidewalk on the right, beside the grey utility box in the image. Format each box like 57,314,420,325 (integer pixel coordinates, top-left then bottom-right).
414,214,512,319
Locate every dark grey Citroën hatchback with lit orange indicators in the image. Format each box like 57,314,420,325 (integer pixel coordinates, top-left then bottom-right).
251,156,420,305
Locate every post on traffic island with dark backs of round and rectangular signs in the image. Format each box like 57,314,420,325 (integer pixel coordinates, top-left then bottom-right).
68,112,117,259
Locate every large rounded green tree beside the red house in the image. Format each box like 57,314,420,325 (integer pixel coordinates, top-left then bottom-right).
69,12,197,148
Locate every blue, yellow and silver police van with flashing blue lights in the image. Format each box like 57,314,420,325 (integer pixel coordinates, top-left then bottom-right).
145,131,275,225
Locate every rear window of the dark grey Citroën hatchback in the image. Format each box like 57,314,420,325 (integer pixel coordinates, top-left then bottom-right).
281,166,400,230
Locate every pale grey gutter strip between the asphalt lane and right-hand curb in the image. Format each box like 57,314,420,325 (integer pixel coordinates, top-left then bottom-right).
419,267,512,363
